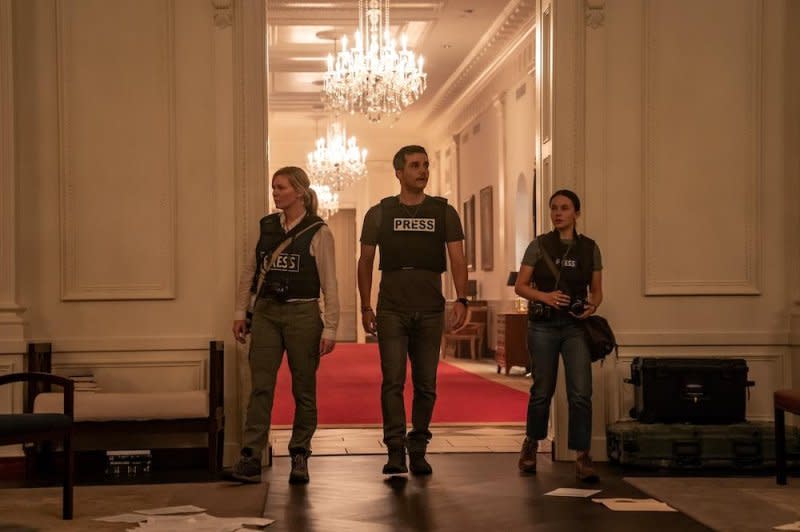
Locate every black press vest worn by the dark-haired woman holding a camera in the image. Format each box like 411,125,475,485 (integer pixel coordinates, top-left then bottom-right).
533,231,595,314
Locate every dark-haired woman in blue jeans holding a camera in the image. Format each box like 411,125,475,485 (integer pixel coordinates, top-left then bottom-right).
514,190,603,482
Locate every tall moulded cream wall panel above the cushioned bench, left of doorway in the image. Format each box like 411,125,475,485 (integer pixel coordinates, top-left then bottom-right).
56,0,176,300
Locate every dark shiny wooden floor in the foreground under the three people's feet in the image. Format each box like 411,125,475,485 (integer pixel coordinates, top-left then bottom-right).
263,453,710,532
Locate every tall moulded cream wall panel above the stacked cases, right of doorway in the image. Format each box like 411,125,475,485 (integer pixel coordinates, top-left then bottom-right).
642,0,764,295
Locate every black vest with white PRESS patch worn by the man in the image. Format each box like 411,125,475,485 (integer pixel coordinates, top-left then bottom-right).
378,196,447,273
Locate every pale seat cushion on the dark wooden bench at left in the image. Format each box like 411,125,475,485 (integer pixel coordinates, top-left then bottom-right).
33,390,208,422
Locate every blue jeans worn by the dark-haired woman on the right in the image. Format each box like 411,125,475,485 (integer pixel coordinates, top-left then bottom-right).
525,318,592,451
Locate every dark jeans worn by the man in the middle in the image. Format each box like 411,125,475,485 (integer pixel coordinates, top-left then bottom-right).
375,308,444,452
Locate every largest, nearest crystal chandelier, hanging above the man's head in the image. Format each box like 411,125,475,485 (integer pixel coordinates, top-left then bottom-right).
322,0,427,122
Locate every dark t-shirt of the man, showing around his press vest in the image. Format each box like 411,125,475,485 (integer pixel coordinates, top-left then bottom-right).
361,196,464,312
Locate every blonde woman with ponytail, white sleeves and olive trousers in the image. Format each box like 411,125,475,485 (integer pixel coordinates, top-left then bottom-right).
227,166,339,484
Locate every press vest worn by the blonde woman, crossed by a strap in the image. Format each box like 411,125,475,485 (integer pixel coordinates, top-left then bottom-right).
250,214,322,299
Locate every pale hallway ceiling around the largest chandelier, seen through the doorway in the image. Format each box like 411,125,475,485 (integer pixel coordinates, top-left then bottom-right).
267,0,534,129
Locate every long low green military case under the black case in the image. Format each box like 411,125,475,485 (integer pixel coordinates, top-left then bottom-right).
606,421,800,470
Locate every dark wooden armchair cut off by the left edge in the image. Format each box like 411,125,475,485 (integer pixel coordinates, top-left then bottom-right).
0,372,75,519
